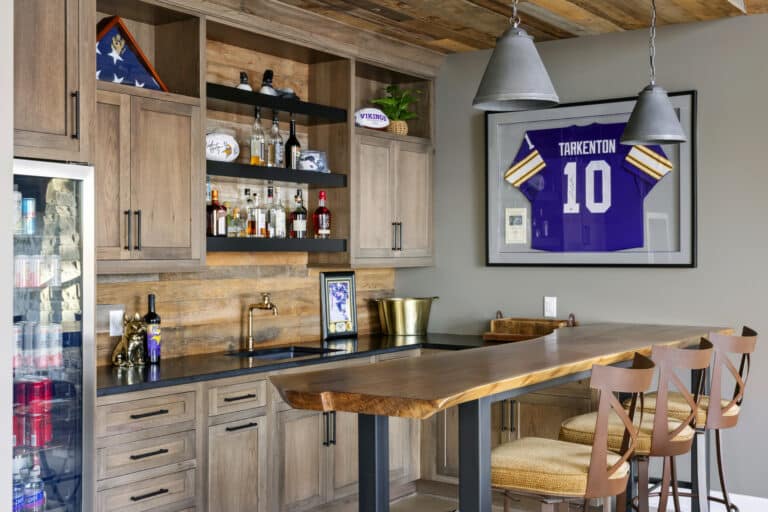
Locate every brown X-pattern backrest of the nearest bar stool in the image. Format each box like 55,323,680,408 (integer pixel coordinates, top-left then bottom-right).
586,354,655,498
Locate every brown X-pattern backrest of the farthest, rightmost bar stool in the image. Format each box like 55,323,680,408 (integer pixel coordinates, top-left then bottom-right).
707,327,757,429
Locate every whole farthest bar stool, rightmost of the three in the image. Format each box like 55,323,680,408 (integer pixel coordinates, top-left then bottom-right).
645,327,757,512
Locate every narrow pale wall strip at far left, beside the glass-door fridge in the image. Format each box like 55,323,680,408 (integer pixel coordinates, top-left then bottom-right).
0,2,13,504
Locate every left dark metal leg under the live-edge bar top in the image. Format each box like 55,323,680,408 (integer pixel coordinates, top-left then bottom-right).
357,414,389,512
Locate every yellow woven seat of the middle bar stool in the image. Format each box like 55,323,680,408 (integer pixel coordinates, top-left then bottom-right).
560,412,695,455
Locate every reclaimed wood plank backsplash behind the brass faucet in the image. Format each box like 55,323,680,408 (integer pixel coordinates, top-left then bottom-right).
96,253,395,365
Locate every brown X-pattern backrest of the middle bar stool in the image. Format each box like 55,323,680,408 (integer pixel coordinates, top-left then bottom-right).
651,338,713,455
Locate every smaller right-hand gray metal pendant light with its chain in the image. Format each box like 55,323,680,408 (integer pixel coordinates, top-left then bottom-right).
621,0,688,145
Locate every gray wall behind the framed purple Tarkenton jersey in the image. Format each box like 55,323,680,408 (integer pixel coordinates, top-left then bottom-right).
397,16,768,497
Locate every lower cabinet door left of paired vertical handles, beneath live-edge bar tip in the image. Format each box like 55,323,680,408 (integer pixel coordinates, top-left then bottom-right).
274,410,329,512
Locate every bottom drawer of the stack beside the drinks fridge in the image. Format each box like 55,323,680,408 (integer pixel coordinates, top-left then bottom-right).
96,469,195,512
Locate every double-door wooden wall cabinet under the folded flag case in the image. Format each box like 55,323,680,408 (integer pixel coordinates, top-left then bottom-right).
95,90,204,273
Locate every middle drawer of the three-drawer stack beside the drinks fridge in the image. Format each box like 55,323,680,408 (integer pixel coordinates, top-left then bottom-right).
96,430,195,480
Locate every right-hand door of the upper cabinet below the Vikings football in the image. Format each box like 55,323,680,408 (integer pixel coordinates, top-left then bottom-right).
395,142,432,258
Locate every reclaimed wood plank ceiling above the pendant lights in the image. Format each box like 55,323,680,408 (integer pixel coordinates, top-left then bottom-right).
282,0,768,53
